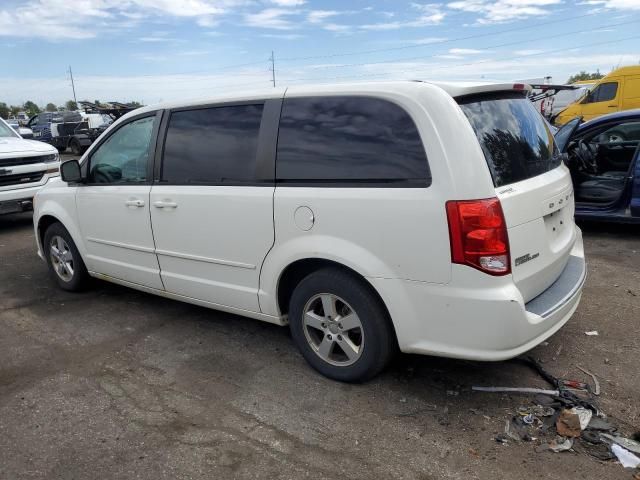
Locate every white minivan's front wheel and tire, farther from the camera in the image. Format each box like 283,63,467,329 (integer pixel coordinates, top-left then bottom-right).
43,223,89,292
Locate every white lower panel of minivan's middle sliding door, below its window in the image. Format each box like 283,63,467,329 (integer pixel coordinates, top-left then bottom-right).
150,185,274,312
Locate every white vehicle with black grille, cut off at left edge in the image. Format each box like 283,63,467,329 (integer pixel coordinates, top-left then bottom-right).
0,118,60,215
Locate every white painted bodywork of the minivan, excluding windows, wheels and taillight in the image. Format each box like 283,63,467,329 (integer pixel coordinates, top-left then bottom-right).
34,82,586,360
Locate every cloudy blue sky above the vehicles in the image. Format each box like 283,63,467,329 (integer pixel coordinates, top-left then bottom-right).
0,0,640,104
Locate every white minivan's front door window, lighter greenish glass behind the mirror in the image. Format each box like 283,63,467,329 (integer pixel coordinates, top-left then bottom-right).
89,116,155,184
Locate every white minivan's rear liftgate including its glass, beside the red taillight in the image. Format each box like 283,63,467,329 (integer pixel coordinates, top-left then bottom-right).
458,91,576,302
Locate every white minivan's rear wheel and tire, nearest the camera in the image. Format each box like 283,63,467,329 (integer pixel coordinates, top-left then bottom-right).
289,268,397,382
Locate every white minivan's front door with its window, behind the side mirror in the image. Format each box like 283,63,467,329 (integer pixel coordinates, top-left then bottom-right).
76,113,163,289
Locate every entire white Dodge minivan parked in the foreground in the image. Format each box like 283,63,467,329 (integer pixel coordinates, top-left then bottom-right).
34,81,586,381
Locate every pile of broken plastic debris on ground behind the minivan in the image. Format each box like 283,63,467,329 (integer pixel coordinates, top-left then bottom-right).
472,356,640,472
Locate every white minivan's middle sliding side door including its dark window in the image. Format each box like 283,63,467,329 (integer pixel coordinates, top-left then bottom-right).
151,100,280,312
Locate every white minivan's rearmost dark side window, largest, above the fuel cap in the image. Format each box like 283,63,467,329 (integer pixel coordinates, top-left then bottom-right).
276,97,430,186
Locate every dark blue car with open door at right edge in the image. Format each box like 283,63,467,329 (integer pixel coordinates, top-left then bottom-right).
555,109,640,223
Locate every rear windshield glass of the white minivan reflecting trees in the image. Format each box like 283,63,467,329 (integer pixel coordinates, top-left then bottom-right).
458,92,562,187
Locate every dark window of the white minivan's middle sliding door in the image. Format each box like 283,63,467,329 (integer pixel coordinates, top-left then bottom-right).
161,105,263,184
